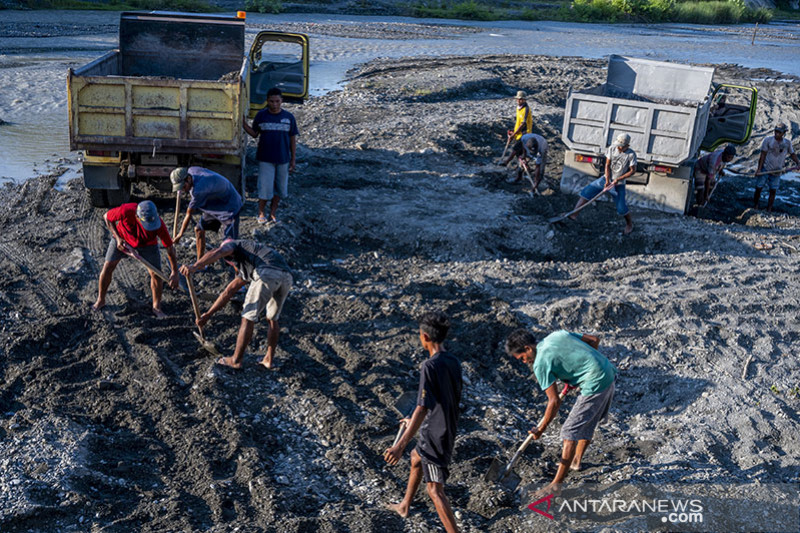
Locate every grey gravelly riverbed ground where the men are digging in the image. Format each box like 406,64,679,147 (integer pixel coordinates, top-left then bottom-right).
0,56,800,533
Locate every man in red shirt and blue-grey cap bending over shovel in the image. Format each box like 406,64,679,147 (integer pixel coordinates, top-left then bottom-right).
92,200,178,318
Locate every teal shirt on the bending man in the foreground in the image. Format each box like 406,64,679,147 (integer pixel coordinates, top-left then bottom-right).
532,330,617,396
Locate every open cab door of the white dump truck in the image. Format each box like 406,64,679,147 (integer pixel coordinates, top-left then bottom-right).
700,84,758,152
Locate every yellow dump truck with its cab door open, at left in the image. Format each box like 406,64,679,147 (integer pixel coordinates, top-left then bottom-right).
67,12,309,207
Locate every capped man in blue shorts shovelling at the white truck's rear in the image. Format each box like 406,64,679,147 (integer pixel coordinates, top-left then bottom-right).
569,133,636,235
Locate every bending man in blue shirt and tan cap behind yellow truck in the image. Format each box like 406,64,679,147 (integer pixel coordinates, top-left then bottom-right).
170,167,243,259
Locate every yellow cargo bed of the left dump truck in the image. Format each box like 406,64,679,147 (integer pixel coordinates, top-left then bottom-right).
67,13,249,154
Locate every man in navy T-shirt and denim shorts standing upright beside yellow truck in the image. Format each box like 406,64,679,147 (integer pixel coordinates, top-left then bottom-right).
242,87,298,224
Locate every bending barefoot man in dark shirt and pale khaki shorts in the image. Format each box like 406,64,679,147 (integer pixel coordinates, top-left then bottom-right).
181,239,292,369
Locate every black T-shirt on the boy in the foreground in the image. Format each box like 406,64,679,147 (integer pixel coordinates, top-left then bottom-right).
417,352,462,467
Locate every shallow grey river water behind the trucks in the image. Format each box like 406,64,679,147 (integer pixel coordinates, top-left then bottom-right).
0,11,800,181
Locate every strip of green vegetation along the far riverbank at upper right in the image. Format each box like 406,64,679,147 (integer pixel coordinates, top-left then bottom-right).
411,0,772,24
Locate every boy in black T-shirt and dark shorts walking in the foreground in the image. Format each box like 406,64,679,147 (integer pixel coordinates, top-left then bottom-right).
383,312,462,533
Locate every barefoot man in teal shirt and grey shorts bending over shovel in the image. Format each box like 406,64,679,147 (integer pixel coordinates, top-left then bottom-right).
506,329,617,497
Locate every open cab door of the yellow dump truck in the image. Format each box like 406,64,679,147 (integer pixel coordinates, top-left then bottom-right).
250,31,309,112
